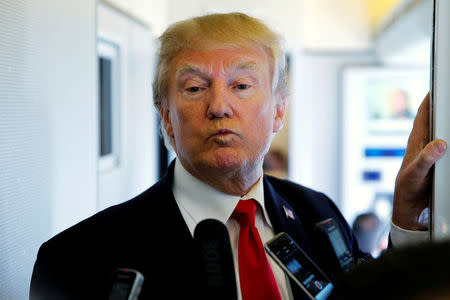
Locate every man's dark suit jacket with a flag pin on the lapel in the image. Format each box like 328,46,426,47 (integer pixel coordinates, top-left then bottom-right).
30,163,365,300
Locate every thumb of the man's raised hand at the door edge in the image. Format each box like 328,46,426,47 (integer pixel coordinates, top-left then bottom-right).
408,140,447,182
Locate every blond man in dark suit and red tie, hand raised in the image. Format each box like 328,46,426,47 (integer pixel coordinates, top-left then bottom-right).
30,14,445,300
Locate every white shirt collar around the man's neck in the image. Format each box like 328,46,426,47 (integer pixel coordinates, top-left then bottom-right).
173,160,272,234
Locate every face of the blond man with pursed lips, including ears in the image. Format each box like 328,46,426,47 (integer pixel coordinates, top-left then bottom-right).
162,45,285,178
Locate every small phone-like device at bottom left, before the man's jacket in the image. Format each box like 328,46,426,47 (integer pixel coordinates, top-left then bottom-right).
107,269,144,300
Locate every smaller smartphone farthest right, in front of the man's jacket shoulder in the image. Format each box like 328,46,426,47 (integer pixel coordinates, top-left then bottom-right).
316,218,355,272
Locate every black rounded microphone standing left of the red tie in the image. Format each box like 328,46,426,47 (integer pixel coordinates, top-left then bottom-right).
194,219,237,300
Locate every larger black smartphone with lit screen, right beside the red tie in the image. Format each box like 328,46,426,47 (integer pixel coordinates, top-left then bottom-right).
264,232,333,300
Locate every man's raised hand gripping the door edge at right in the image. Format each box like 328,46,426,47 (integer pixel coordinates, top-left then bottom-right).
391,94,447,246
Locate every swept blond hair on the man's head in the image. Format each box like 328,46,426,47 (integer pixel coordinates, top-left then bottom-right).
153,13,286,146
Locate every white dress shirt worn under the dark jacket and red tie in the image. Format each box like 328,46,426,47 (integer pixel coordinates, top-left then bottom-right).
172,160,294,300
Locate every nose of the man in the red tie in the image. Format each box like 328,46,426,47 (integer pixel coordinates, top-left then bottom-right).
207,83,233,120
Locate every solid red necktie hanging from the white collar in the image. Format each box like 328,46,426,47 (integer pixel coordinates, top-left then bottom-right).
232,199,281,300
